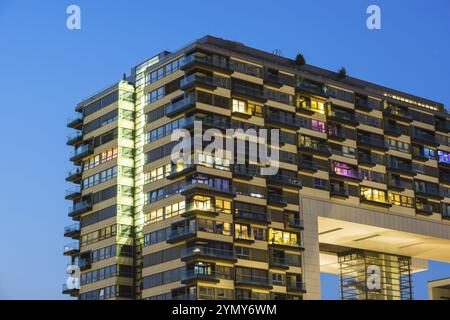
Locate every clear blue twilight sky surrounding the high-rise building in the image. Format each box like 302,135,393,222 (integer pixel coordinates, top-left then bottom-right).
0,0,450,299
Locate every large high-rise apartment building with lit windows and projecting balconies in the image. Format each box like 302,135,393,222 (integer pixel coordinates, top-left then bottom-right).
63,36,450,300
